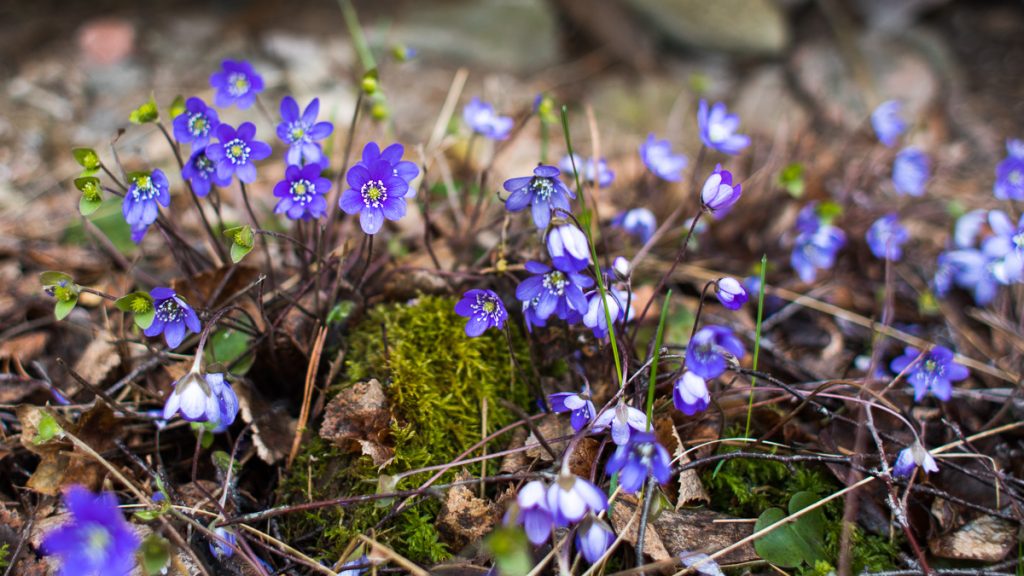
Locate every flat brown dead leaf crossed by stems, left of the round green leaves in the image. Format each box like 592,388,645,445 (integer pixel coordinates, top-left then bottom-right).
611,496,759,564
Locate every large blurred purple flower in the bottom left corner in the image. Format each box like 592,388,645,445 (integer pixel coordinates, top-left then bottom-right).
41,485,141,576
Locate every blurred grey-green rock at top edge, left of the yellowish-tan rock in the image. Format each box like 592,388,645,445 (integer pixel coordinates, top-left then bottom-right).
389,0,560,72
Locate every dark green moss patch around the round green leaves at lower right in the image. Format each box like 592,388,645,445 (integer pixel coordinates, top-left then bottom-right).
702,430,900,576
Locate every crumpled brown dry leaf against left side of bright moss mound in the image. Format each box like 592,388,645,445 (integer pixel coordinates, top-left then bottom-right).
319,378,394,467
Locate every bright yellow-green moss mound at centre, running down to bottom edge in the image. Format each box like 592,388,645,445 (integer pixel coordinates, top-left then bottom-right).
281,296,529,564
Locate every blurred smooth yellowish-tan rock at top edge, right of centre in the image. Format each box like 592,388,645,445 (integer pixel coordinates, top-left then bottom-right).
624,0,790,55
